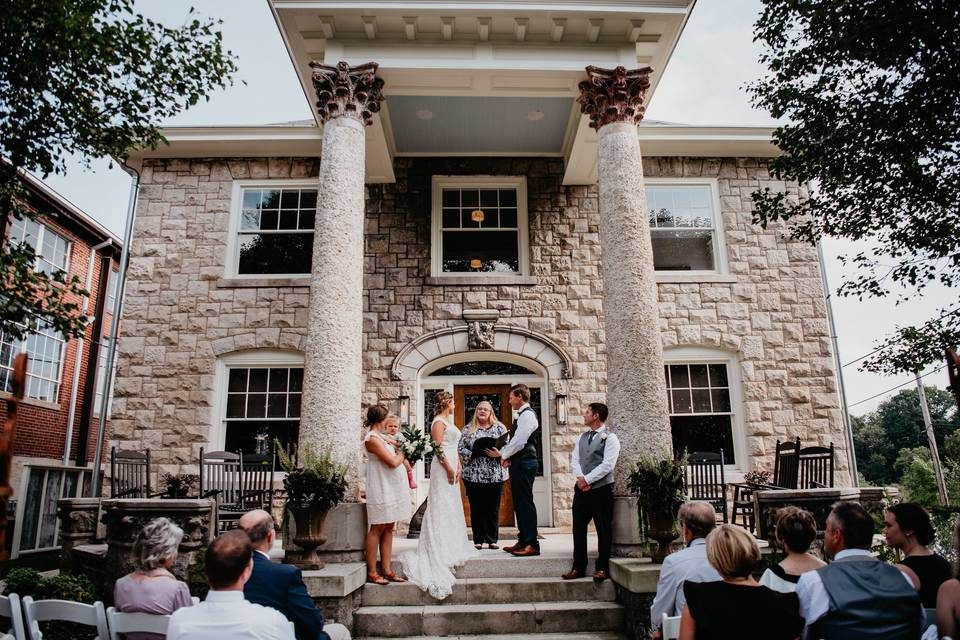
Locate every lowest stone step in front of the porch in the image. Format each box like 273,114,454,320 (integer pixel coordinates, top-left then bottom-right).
353,604,624,638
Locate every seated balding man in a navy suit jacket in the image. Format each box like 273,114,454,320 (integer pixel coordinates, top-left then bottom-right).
239,509,350,640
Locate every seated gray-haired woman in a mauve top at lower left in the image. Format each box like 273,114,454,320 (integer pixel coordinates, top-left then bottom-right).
113,518,193,640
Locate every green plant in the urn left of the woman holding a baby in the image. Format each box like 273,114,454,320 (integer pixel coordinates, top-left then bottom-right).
277,446,347,511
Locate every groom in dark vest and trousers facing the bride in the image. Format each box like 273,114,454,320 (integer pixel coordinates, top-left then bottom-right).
487,384,540,557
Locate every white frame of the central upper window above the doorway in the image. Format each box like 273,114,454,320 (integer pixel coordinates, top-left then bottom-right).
430,176,530,281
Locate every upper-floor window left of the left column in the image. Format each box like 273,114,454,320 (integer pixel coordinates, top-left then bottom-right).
228,181,317,277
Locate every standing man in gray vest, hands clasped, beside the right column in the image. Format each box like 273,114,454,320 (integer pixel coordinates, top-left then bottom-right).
562,402,620,582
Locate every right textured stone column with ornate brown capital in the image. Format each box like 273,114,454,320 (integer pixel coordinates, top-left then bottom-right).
579,67,672,555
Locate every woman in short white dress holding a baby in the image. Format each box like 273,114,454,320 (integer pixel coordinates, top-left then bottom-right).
363,404,410,585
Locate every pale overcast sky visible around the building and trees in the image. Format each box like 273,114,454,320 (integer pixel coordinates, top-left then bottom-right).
39,0,955,415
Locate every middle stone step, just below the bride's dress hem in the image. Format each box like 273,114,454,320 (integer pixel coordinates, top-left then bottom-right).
362,577,616,607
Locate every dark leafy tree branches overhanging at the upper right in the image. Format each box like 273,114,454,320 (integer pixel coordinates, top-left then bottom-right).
749,0,960,373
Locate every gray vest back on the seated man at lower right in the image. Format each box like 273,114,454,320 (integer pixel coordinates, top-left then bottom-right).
810,556,920,640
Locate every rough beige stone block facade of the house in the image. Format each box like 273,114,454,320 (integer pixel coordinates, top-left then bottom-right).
113,157,849,525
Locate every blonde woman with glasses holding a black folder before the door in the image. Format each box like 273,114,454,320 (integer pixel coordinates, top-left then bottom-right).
460,400,507,549
